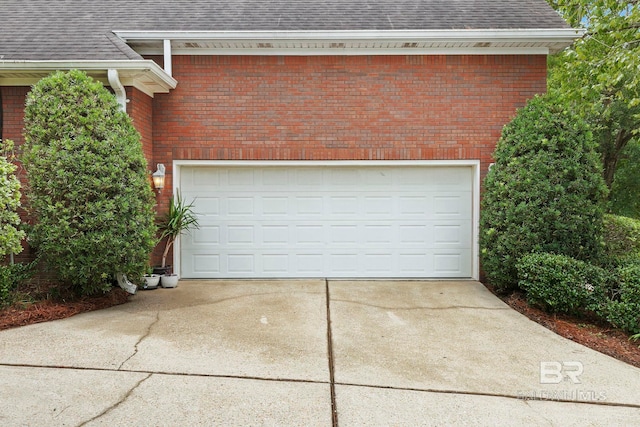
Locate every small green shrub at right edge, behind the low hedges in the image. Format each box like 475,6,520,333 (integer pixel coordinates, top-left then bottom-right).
604,215,640,265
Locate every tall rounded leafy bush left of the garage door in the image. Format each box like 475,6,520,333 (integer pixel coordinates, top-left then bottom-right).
23,71,156,294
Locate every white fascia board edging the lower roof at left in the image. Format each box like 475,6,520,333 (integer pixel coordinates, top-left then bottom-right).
0,59,178,93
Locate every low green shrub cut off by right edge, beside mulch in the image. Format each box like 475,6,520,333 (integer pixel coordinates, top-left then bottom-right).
600,264,640,334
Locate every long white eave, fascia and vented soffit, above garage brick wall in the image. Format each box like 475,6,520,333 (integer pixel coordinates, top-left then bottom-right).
114,28,584,55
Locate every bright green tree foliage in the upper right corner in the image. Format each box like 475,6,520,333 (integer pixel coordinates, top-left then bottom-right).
548,0,640,196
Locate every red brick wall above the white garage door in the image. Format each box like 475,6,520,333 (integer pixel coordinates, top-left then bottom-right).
153,55,546,191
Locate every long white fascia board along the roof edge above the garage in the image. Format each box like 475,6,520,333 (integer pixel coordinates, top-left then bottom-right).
114,28,584,42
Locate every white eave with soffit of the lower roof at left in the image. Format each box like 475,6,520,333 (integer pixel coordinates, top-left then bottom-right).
0,60,178,96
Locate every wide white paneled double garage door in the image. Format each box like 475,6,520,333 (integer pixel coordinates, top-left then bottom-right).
179,165,473,278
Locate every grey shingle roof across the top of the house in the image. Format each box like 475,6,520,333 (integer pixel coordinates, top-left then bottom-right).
0,0,569,60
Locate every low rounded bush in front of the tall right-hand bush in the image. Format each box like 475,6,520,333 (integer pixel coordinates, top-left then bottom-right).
516,253,610,315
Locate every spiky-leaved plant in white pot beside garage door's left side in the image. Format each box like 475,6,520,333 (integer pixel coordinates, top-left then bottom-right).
158,192,198,288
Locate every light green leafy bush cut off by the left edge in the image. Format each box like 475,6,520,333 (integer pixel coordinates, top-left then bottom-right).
0,140,24,258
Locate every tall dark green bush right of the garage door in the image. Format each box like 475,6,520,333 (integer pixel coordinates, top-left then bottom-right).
480,97,607,291
